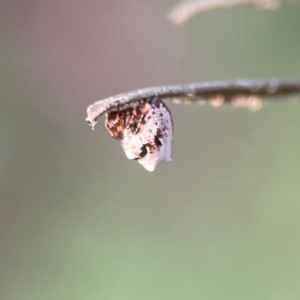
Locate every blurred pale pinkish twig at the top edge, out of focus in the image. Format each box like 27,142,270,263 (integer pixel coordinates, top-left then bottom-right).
168,0,299,24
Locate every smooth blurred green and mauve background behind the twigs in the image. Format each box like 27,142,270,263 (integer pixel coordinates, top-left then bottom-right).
0,0,300,300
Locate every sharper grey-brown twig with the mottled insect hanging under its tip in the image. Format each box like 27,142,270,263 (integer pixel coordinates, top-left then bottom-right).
86,78,300,128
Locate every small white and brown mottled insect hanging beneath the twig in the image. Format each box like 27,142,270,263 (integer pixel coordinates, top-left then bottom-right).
105,97,173,172
